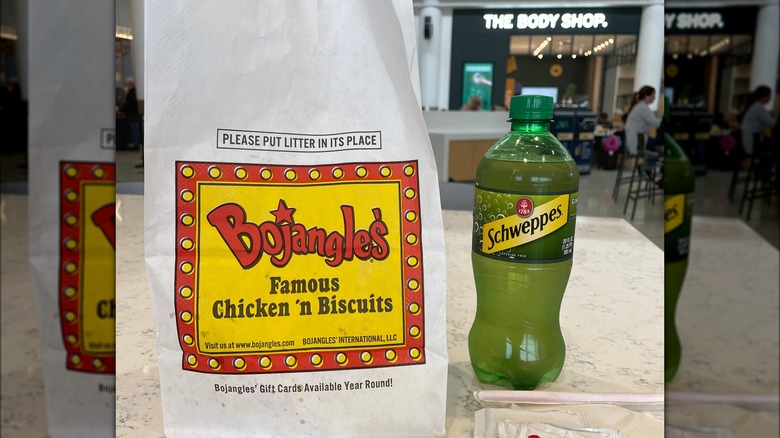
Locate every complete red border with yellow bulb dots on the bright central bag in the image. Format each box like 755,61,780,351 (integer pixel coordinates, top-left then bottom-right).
173,161,425,374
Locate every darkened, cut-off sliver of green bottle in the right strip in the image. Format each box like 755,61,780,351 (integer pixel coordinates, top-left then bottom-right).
664,134,696,382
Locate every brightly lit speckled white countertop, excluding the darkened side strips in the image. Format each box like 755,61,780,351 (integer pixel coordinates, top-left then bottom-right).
116,195,663,438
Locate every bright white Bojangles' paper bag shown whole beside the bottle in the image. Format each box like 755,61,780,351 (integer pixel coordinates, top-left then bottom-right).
145,1,447,437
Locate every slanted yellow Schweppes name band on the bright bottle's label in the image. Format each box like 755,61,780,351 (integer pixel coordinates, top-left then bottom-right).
482,195,569,254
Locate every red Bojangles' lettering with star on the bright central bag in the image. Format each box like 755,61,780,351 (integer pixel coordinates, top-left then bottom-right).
206,199,390,269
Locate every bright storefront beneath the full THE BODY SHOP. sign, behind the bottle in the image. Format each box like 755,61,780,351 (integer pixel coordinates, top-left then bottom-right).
449,7,642,114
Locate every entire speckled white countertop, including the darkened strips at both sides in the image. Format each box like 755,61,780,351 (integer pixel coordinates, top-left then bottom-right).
0,194,780,438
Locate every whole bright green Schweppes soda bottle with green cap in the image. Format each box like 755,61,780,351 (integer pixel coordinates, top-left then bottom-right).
469,96,580,389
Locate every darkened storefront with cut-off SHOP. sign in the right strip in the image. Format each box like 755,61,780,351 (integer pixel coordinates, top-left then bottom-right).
664,6,777,174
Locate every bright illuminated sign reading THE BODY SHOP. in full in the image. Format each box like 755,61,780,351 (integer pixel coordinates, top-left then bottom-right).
482,12,609,29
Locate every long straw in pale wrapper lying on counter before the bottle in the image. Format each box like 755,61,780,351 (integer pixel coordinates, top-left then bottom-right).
474,390,664,405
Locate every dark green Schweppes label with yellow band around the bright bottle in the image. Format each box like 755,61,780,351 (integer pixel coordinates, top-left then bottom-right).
473,189,577,263
